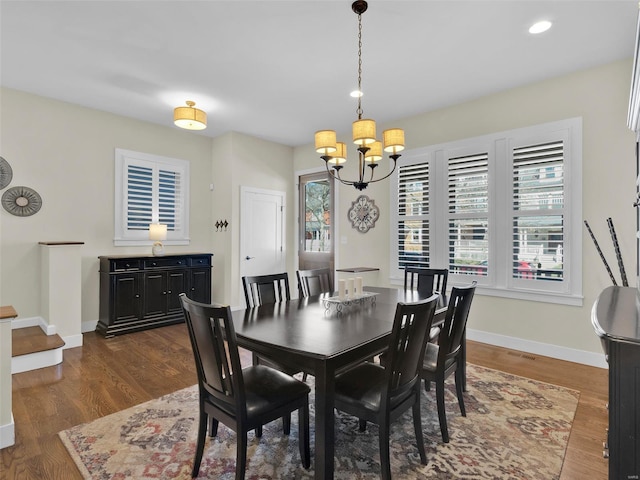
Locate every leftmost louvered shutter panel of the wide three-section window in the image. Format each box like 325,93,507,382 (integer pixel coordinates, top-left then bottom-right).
398,163,429,269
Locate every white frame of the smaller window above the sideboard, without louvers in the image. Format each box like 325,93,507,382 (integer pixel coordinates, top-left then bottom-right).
113,148,190,246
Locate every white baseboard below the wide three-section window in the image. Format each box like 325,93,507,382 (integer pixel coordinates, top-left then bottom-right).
467,329,609,368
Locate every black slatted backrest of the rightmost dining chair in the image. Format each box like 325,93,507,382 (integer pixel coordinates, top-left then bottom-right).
438,282,477,364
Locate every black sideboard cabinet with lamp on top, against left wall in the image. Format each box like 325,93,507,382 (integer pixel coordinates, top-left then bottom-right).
96,253,212,337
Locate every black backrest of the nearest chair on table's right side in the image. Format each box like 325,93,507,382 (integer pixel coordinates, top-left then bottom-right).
383,294,438,401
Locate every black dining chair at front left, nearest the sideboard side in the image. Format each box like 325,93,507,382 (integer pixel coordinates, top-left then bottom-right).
179,293,311,480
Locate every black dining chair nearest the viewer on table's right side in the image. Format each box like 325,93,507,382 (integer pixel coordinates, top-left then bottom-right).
335,295,438,480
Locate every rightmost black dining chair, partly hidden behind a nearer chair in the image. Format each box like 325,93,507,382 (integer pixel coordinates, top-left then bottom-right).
420,282,476,443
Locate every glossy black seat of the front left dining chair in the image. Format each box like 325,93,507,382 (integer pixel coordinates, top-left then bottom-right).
242,365,311,418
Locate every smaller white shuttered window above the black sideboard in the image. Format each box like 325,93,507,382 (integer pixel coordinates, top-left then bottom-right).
114,149,189,245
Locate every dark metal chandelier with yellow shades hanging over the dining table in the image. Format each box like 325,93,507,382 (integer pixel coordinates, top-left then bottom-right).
315,0,404,190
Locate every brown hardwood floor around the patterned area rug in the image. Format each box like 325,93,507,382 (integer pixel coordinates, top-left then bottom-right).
0,324,608,480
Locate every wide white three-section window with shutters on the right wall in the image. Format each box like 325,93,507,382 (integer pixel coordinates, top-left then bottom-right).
391,119,582,305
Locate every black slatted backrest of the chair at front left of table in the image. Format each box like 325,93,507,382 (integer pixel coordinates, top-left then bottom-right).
180,293,246,415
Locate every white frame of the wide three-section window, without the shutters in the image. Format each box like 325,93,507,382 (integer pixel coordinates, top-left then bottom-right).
389,117,583,306
